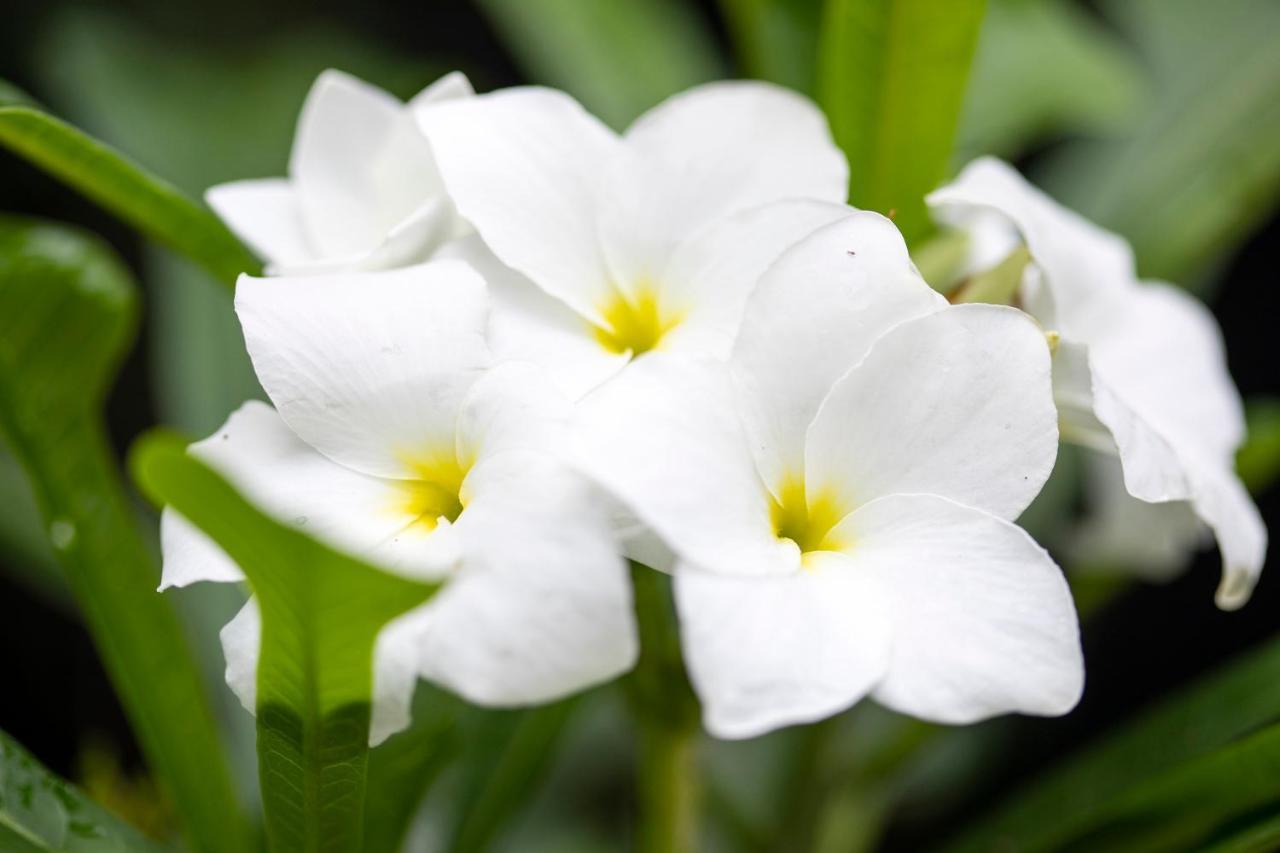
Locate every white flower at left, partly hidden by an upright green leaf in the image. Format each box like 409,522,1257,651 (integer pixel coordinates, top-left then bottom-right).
161,261,636,743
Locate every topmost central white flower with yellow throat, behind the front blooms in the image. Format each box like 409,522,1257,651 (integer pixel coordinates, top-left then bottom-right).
420,82,847,396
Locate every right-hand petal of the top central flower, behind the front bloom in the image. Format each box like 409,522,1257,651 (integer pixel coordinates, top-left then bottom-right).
658,199,851,357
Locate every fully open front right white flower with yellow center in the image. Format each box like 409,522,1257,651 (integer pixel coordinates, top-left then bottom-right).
575,213,1083,738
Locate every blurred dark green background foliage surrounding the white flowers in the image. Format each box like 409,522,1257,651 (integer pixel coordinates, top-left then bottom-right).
0,0,1280,850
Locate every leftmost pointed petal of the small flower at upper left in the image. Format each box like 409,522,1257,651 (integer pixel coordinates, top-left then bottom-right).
205,178,315,266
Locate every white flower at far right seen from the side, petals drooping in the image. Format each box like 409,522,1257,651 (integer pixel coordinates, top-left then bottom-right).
929,159,1267,610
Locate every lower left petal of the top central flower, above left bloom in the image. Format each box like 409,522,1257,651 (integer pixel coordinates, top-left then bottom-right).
436,234,630,400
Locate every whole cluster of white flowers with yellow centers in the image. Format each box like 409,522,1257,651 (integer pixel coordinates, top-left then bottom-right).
163,72,1265,742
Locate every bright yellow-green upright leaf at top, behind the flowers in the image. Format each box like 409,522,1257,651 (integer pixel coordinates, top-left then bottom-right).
818,0,986,242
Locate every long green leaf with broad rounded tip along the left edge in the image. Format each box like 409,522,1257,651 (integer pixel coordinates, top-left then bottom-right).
0,218,250,853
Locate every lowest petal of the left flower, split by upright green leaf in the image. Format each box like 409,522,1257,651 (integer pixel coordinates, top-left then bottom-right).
219,598,422,747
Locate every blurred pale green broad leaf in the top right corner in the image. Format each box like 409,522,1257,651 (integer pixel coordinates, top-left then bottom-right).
1042,0,1280,279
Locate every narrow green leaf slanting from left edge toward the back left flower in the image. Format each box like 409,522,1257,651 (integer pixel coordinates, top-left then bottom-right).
0,87,261,287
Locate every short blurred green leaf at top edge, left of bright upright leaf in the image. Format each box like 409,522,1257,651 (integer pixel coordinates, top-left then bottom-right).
719,0,822,93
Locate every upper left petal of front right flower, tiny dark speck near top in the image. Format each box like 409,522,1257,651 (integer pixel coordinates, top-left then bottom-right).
733,211,946,488
